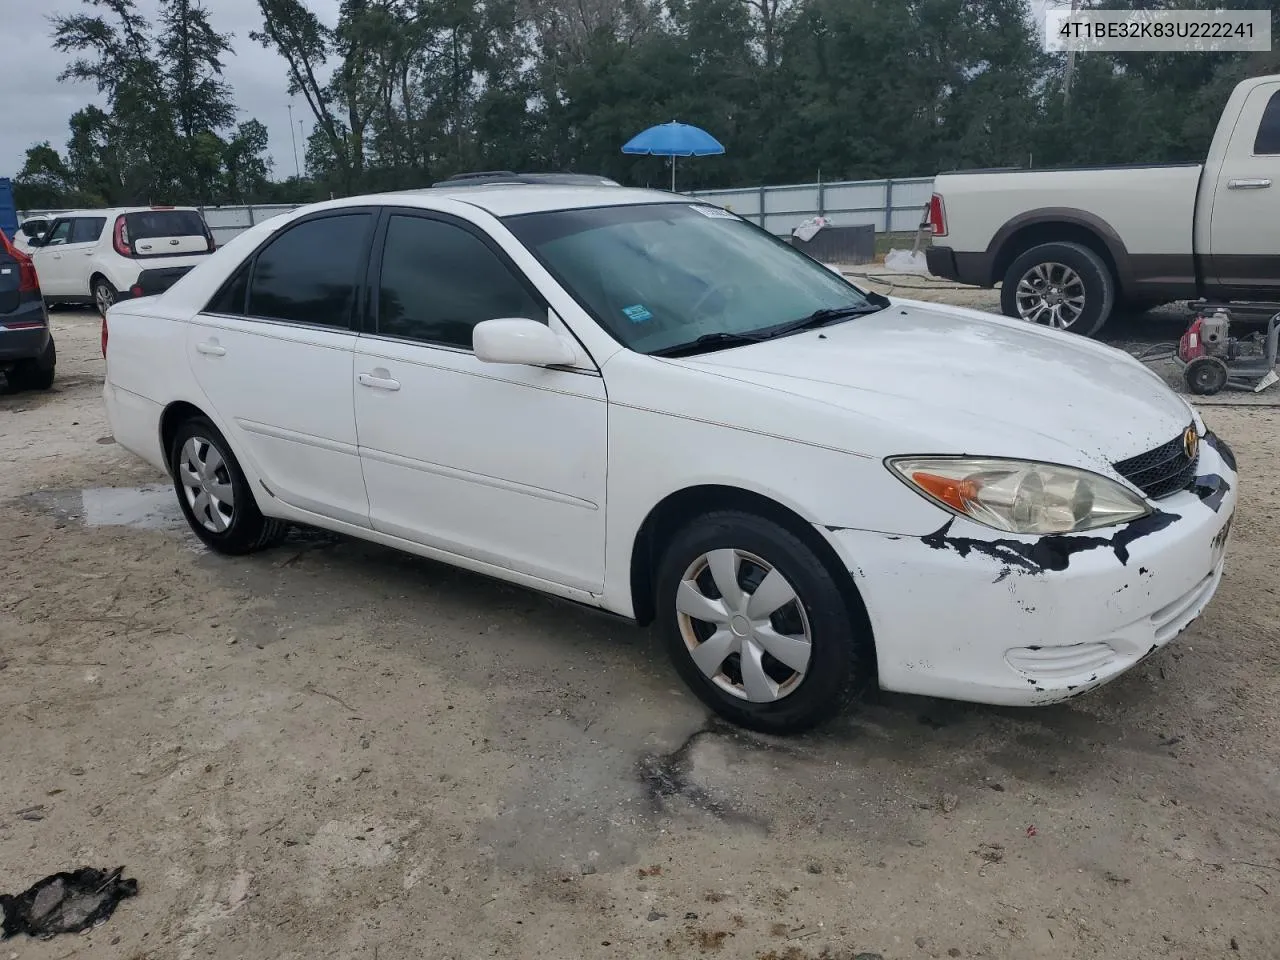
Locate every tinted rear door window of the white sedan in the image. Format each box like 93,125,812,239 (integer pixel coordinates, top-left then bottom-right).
245,214,372,328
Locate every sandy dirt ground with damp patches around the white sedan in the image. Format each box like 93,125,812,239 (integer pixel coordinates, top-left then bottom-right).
0,312,1280,960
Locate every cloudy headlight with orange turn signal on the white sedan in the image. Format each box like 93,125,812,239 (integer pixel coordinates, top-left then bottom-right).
887,457,1151,534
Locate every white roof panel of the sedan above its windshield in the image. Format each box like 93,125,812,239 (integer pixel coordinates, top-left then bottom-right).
364,183,699,218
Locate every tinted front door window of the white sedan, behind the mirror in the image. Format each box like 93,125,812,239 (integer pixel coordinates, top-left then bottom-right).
378,216,547,349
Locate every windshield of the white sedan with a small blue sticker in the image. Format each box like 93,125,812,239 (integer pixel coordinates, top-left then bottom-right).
504,204,887,353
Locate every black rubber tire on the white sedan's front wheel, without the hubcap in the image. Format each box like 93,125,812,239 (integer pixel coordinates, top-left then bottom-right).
655,511,872,733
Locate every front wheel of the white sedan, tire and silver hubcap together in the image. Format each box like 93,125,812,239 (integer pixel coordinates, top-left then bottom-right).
655,511,870,733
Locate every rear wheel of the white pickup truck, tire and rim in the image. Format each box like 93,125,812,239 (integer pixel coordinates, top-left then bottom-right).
1000,243,1116,337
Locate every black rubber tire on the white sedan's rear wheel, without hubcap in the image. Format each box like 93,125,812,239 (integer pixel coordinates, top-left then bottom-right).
169,416,289,557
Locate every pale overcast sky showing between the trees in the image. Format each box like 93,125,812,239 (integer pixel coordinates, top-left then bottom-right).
0,0,1053,179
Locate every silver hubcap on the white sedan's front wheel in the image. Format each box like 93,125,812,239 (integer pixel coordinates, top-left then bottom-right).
676,549,813,703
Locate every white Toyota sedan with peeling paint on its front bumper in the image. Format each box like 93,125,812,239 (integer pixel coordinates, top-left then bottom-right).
102,184,1236,732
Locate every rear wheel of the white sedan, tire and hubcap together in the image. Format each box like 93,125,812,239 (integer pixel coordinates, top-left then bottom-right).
169,417,289,556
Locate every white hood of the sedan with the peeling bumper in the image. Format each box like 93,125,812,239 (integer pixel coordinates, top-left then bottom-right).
684,300,1194,465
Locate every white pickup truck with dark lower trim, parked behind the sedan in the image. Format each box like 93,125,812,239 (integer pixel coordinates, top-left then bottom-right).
927,76,1280,335
